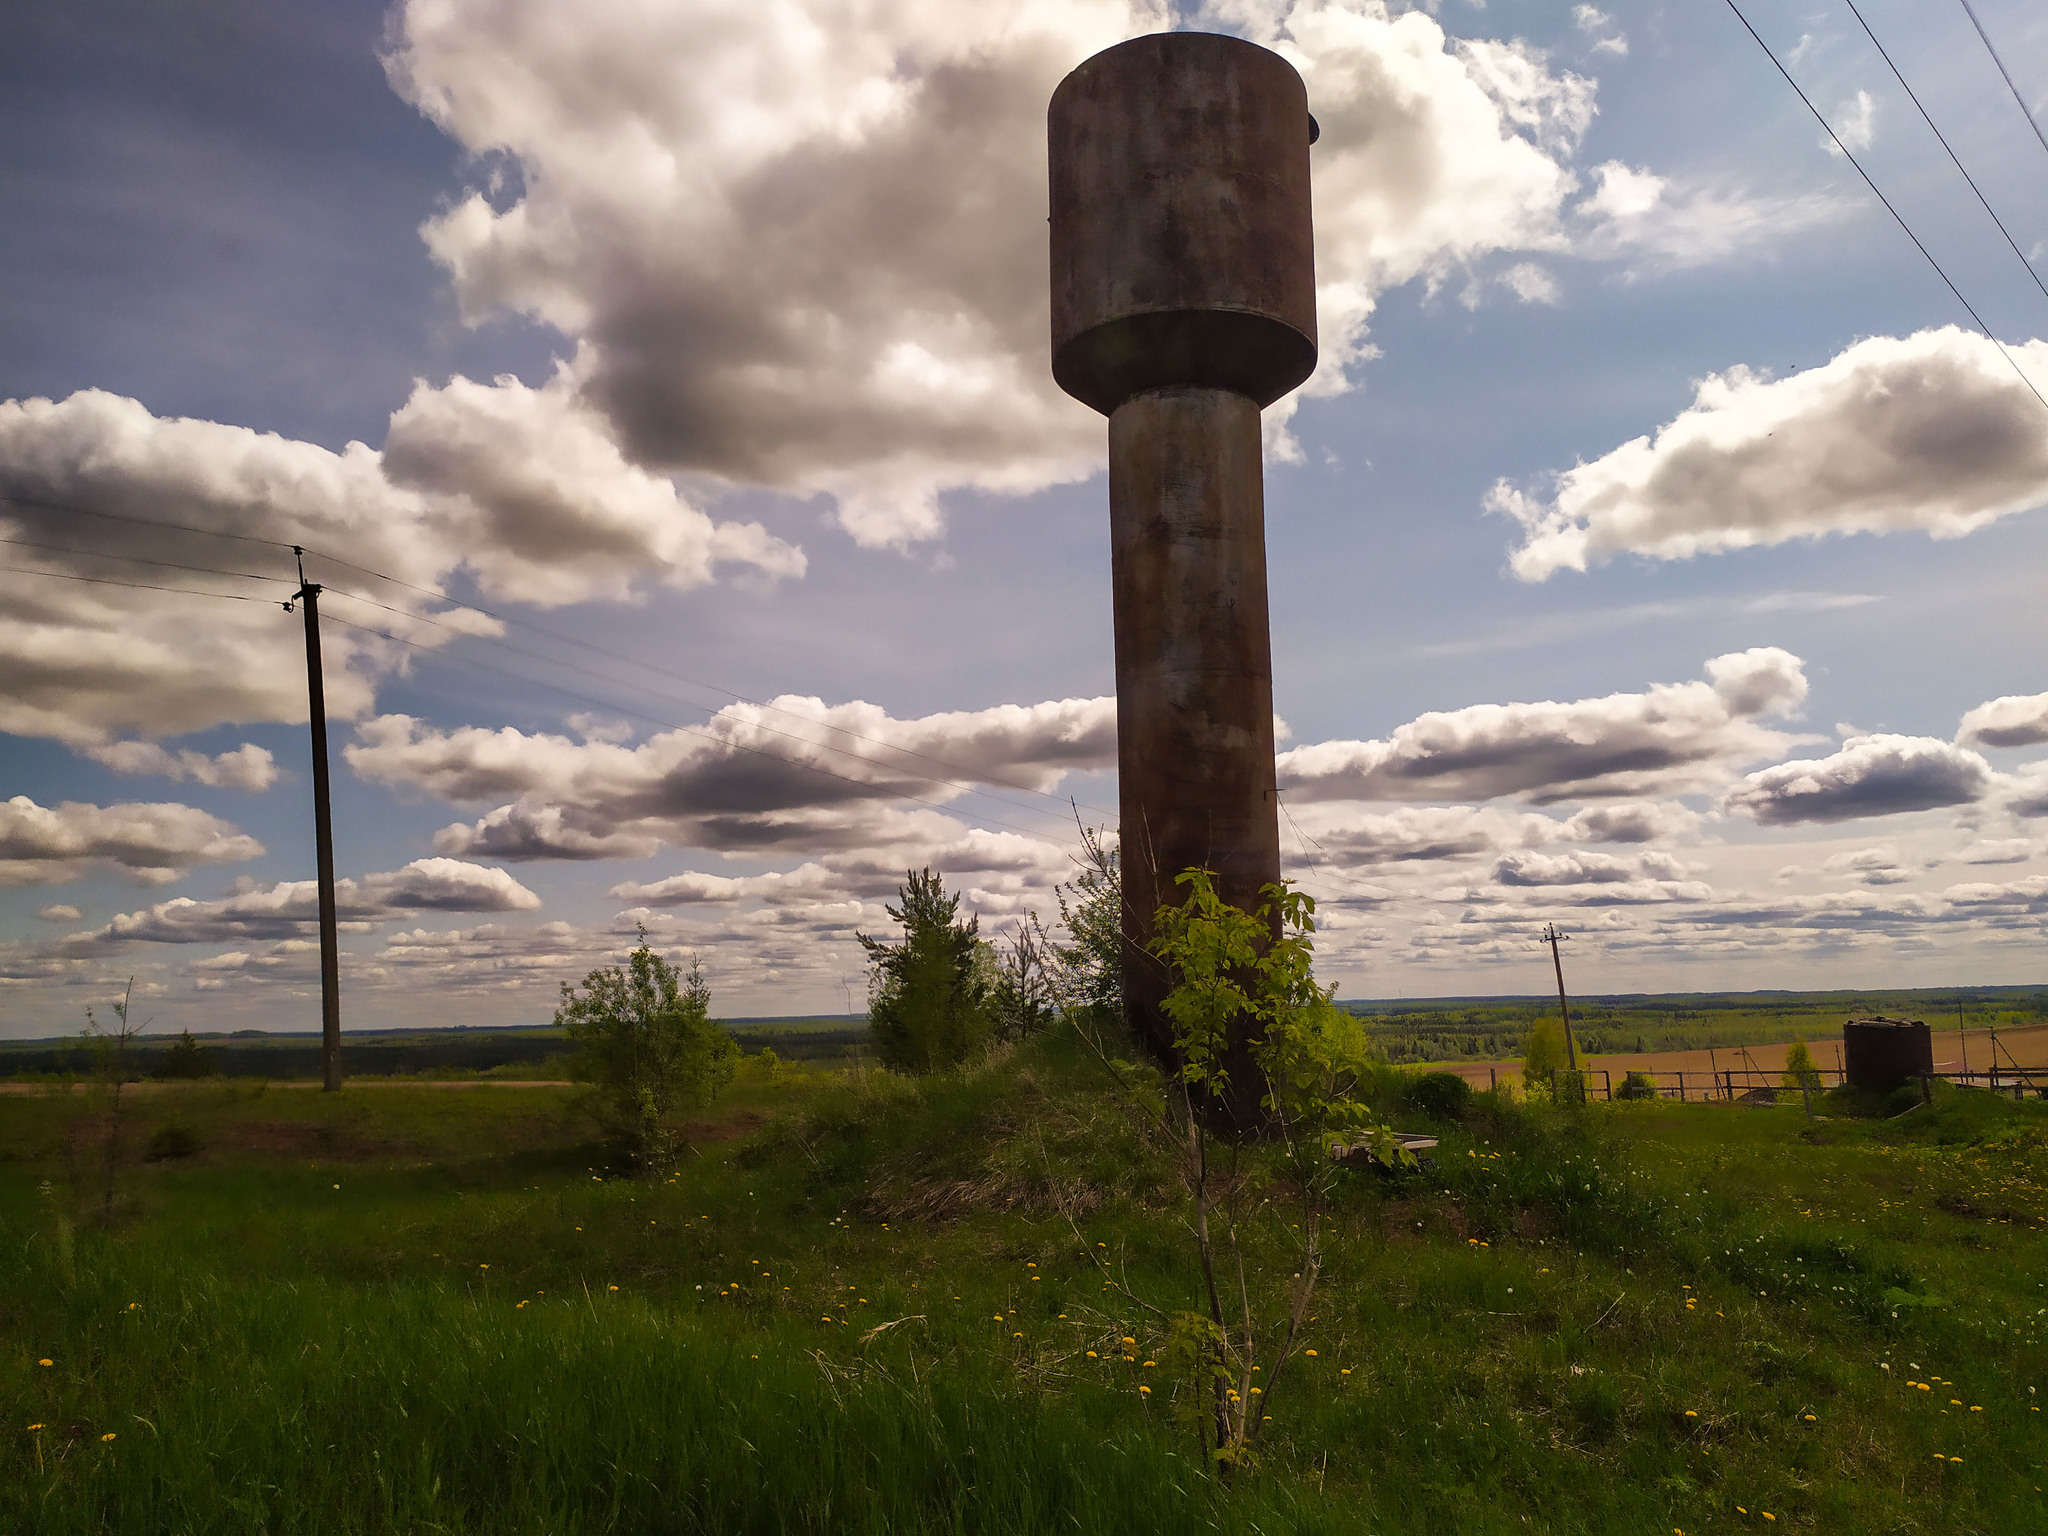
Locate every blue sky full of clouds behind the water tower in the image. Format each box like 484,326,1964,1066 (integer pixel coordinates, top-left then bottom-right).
0,0,2048,1036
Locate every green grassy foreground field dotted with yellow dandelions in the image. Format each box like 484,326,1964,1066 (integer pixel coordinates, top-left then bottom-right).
0,1038,2048,1536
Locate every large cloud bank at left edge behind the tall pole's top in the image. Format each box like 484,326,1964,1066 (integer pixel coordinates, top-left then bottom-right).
0,379,803,753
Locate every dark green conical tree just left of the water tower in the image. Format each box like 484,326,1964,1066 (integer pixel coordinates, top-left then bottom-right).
854,868,991,1071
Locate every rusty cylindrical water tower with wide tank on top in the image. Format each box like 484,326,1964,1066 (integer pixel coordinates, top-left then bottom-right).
1047,33,1315,1130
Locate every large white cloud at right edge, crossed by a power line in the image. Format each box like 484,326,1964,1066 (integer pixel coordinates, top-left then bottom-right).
1487,326,2048,582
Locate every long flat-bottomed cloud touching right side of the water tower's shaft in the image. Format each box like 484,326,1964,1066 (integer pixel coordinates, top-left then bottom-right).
1278,647,1806,805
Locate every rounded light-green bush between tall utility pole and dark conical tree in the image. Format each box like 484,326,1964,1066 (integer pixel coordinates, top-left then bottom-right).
555,934,739,1167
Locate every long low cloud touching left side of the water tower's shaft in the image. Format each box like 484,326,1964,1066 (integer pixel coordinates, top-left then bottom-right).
358,694,1116,860
